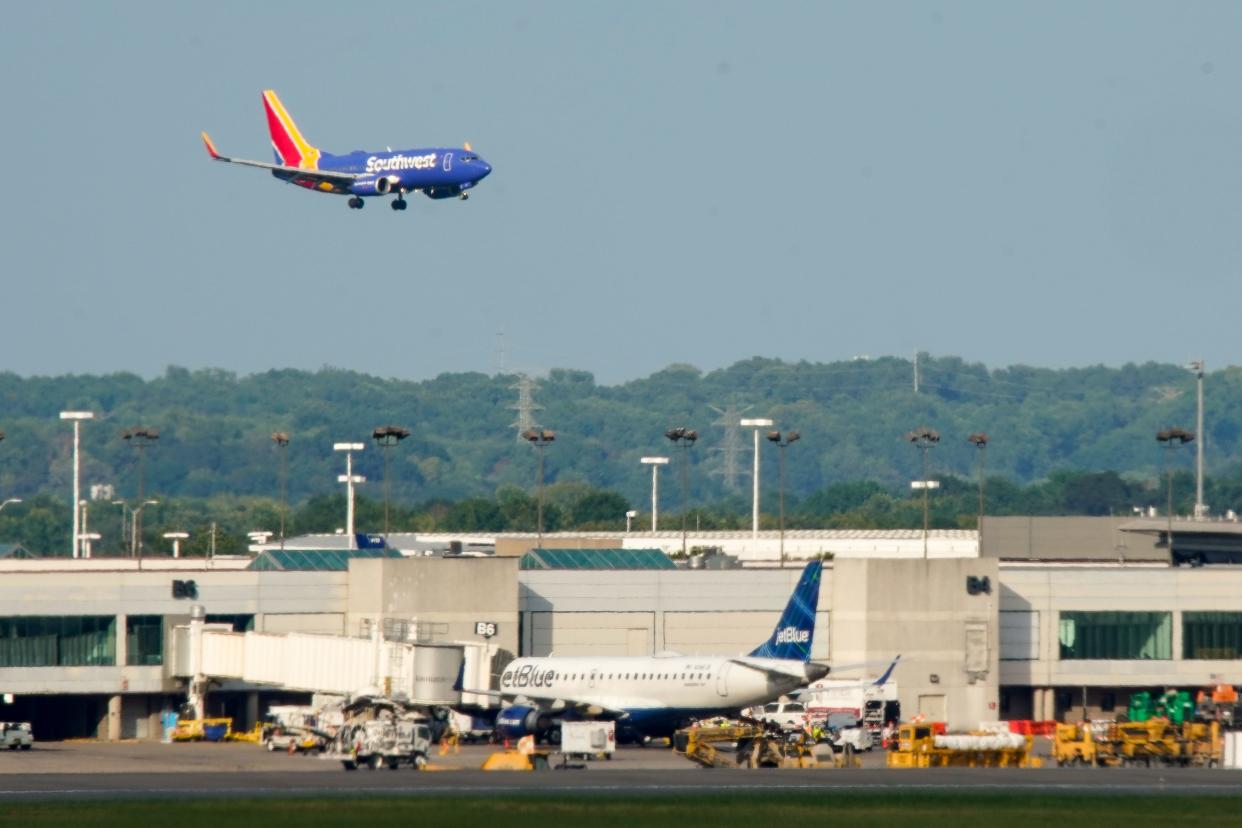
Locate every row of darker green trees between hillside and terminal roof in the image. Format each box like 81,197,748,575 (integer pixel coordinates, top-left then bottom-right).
0,472,1222,556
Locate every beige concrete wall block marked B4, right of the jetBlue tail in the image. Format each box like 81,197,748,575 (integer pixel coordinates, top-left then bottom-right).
831,559,1000,729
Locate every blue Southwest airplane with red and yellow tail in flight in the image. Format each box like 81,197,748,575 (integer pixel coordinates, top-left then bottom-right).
202,89,492,210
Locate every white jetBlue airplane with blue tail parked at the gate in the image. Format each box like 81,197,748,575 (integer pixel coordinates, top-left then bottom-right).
469,561,897,739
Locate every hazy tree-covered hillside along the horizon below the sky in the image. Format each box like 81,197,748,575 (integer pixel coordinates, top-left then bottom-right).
0,358,1242,508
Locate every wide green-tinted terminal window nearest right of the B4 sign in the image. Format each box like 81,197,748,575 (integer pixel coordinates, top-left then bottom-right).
1058,612,1172,660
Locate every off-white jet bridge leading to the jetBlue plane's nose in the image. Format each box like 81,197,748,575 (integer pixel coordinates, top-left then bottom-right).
165,607,492,708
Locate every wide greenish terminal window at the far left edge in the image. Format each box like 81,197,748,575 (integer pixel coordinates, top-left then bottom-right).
0,616,117,667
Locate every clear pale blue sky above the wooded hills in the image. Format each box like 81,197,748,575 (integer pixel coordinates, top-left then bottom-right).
0,1,1242,382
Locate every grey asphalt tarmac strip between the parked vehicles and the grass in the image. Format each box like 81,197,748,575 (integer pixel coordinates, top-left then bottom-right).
0,742,1242,801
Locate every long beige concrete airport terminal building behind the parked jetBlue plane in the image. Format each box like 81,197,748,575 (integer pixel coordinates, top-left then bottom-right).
0,518,1242,739
